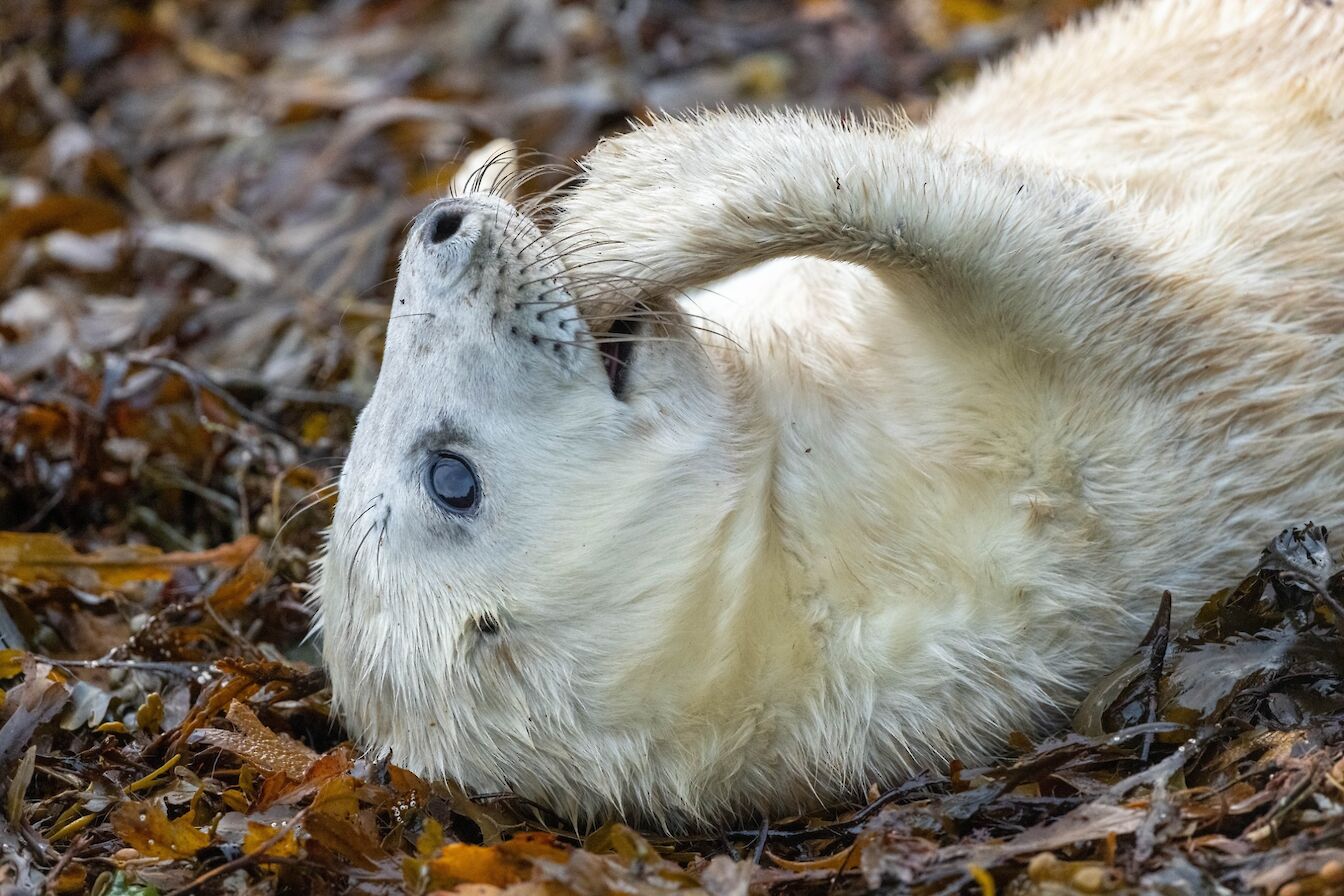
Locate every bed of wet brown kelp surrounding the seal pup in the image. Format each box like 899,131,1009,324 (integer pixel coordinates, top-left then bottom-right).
0,0,1344,896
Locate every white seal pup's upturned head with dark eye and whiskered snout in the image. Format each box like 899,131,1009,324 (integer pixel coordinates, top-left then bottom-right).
317,193,784,817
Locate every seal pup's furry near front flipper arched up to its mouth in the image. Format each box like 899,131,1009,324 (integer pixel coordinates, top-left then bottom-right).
552,113,1189,378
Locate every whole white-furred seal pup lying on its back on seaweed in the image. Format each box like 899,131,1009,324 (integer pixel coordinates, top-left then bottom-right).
319,0,1344,823
